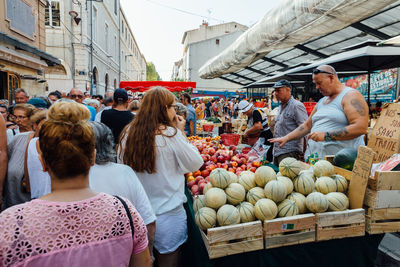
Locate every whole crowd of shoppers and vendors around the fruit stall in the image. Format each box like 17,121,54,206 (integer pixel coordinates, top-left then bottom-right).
0,65,388,266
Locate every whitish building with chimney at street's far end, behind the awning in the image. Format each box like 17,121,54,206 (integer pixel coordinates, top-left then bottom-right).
172,22,247,91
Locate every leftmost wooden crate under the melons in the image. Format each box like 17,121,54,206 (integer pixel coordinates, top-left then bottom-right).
200,221,264,259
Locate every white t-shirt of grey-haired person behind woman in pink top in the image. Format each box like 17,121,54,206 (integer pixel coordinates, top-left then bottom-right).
89,162,156,224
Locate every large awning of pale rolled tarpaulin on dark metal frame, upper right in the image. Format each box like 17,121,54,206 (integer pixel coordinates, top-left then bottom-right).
199,0,400,86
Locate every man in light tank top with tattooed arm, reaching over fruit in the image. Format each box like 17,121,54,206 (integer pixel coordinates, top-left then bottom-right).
271,65,368,158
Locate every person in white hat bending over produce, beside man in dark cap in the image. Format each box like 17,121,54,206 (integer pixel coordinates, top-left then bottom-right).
238,100,272,161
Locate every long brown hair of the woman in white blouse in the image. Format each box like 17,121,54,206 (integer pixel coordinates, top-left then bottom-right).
119,86,176,173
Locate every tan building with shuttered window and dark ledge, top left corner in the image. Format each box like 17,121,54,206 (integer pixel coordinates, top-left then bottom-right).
0,0,61,101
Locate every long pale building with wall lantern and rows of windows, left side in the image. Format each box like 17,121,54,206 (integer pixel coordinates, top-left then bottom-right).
45,0,146,94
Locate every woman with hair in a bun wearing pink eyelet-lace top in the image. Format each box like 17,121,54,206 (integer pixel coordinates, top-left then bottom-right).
0,102,151,267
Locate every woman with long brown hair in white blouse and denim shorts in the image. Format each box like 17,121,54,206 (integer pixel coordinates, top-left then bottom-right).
119,87,203,266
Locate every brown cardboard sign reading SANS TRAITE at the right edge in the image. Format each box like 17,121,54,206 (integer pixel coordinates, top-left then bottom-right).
368,103,400,163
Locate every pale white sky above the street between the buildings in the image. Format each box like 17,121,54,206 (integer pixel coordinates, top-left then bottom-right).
120,0,279,81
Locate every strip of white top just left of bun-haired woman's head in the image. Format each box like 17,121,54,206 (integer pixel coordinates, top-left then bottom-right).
26,137,51,198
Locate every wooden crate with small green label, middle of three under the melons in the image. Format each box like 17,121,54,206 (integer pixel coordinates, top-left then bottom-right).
263,213,315,249
